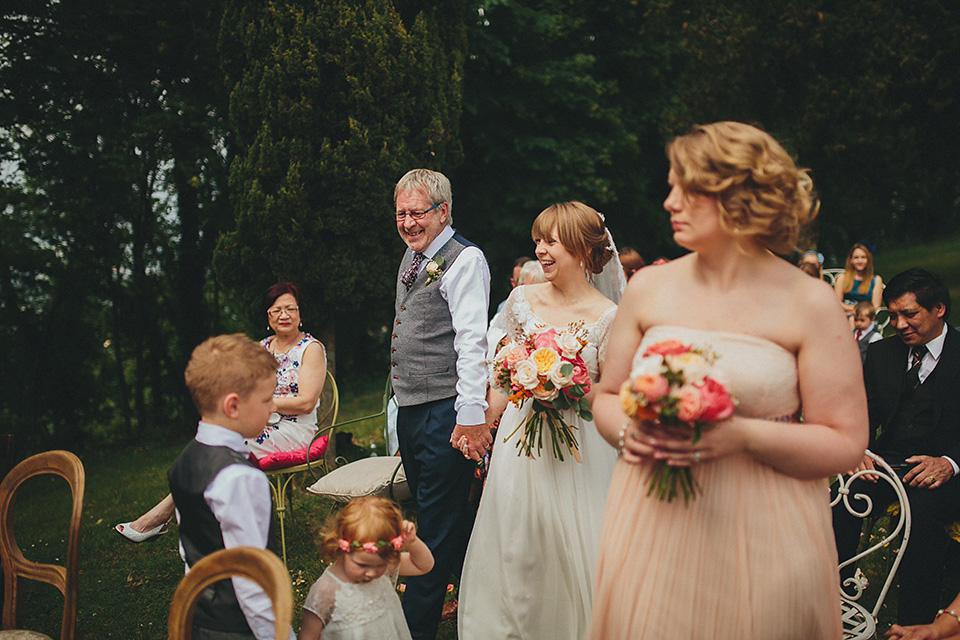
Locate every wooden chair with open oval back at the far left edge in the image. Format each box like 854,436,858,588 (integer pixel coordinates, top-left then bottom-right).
0,451,85,640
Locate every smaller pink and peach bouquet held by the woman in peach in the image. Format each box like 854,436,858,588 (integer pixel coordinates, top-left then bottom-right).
620,340,736,503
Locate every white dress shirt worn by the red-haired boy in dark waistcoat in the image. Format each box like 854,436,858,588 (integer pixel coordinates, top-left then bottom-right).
177,421,296,640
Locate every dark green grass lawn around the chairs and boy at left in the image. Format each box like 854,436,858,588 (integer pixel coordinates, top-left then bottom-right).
7,380,456,640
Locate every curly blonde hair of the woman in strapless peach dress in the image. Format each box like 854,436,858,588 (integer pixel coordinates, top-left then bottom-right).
667,122,820,254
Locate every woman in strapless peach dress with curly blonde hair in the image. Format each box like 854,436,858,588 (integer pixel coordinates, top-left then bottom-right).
590,122,867,640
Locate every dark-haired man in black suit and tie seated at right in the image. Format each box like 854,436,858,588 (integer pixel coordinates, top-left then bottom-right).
834,269,960,624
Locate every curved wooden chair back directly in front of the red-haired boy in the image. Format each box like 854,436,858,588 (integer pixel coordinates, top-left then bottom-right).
167,547,293,640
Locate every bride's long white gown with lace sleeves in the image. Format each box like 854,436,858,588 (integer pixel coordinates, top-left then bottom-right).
458,287,617,640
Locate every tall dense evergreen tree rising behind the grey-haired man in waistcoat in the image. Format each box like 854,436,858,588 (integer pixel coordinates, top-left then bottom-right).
216,0,472,371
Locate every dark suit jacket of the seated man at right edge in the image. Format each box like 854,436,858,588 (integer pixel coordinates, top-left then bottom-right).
863,325,960,461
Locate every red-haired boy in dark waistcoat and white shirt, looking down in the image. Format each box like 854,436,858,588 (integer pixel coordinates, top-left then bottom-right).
167,333,294,640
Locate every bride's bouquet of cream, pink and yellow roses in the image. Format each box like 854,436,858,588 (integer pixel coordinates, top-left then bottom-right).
493,322,593,462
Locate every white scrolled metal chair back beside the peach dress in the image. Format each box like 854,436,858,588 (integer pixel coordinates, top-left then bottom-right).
830,450,911,620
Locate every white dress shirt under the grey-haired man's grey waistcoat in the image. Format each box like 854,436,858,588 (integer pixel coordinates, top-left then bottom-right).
420,227,490,425
